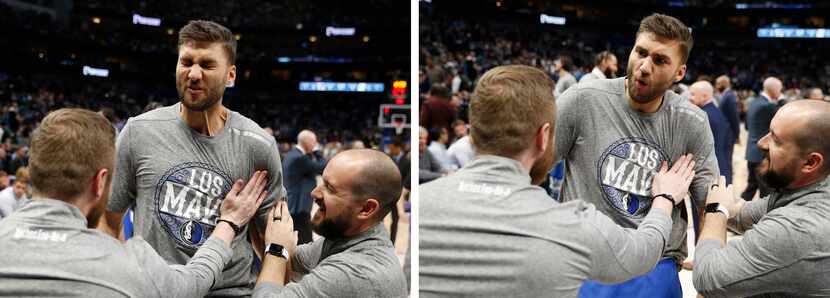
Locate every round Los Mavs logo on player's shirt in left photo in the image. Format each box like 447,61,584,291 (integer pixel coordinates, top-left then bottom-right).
155,162,232,249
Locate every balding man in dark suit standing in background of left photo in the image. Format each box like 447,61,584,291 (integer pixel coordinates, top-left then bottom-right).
282,130,326,244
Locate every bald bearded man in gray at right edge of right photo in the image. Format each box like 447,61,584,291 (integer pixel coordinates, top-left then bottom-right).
693,100,830,297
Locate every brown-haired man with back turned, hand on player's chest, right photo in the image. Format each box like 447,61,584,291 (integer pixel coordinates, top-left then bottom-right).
418,66,694,297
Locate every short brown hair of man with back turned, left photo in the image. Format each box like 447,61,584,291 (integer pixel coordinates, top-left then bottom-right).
29,109,115,200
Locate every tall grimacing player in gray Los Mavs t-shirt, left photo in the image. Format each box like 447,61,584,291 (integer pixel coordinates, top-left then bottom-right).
101,21,285,296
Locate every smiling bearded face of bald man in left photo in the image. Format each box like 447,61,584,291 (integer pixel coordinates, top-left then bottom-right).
311,158,362,238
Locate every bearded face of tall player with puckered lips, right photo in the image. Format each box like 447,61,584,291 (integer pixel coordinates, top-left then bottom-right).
626,32,686,103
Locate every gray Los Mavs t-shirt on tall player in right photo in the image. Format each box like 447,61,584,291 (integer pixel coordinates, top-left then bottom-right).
556,78,719,264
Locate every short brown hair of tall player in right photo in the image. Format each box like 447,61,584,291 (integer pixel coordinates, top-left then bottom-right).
637,13,694,64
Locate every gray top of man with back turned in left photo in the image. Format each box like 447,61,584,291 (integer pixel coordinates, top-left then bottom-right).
0,199,231,297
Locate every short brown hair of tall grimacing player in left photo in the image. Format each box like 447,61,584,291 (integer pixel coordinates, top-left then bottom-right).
178,20,236,65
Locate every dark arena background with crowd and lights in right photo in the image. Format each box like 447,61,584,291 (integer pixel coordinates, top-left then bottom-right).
418,0,830,297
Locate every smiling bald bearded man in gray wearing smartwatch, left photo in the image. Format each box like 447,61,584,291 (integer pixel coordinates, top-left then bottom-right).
254,149,407,297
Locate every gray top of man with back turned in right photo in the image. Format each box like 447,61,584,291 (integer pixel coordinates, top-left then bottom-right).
419,155,672,297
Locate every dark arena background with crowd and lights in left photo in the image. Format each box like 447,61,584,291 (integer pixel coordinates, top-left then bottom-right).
0,0,413,278
